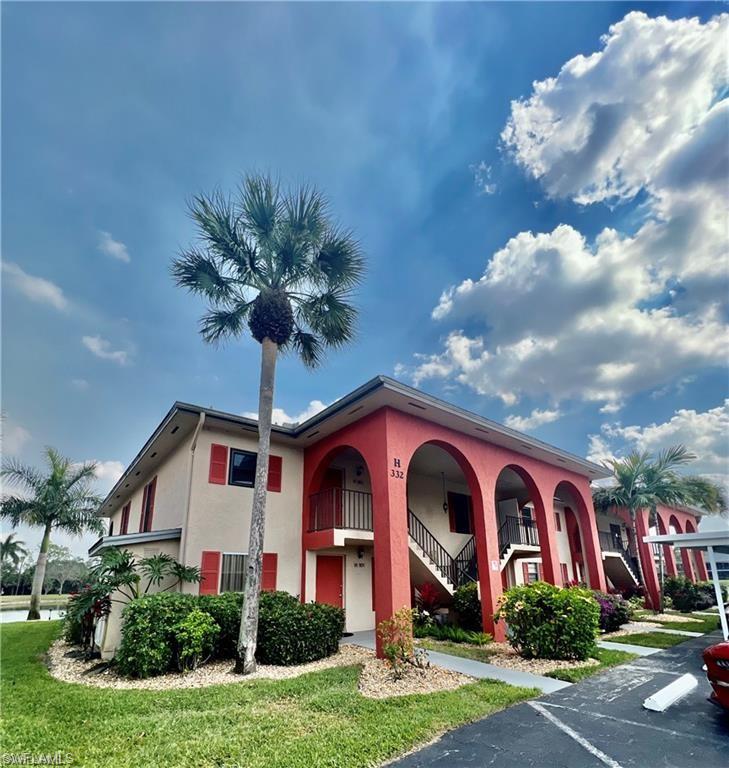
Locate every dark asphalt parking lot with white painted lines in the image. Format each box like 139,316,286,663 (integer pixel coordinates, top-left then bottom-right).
393,632,729,768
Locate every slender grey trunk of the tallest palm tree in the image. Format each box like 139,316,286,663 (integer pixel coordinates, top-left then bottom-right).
235,338,278,675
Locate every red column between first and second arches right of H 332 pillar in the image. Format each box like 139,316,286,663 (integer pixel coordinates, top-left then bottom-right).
472,477,506,643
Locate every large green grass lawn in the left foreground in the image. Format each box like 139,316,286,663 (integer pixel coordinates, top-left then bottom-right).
0,622,538,768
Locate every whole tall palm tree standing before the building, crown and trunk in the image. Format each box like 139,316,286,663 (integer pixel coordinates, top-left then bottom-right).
172,174,364,674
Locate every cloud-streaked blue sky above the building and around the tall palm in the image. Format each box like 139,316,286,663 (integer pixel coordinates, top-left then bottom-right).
2,3,729,551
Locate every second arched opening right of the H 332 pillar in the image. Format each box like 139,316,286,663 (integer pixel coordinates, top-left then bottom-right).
495,464,552,587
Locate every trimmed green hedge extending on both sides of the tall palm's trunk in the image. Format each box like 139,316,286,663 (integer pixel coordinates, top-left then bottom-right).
115,592,344,678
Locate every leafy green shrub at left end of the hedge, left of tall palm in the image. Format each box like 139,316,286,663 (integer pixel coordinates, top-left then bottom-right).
115,592,196,677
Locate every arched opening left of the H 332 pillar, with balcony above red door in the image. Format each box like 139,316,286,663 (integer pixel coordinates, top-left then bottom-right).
302,445,375,632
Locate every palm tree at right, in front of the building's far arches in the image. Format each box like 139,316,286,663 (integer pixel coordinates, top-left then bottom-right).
592,445,727,610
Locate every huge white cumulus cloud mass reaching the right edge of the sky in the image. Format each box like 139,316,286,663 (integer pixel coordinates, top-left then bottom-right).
407,13,729,413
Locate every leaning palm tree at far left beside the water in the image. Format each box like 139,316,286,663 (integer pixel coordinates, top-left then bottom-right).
0,448,104,620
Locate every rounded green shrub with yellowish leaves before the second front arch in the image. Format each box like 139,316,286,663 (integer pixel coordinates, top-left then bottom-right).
496,581,600,660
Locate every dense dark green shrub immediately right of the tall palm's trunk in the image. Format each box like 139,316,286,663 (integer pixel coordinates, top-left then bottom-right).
256,592,344,666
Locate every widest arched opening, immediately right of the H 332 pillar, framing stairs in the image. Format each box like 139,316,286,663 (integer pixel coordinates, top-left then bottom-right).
406,441,479,614
